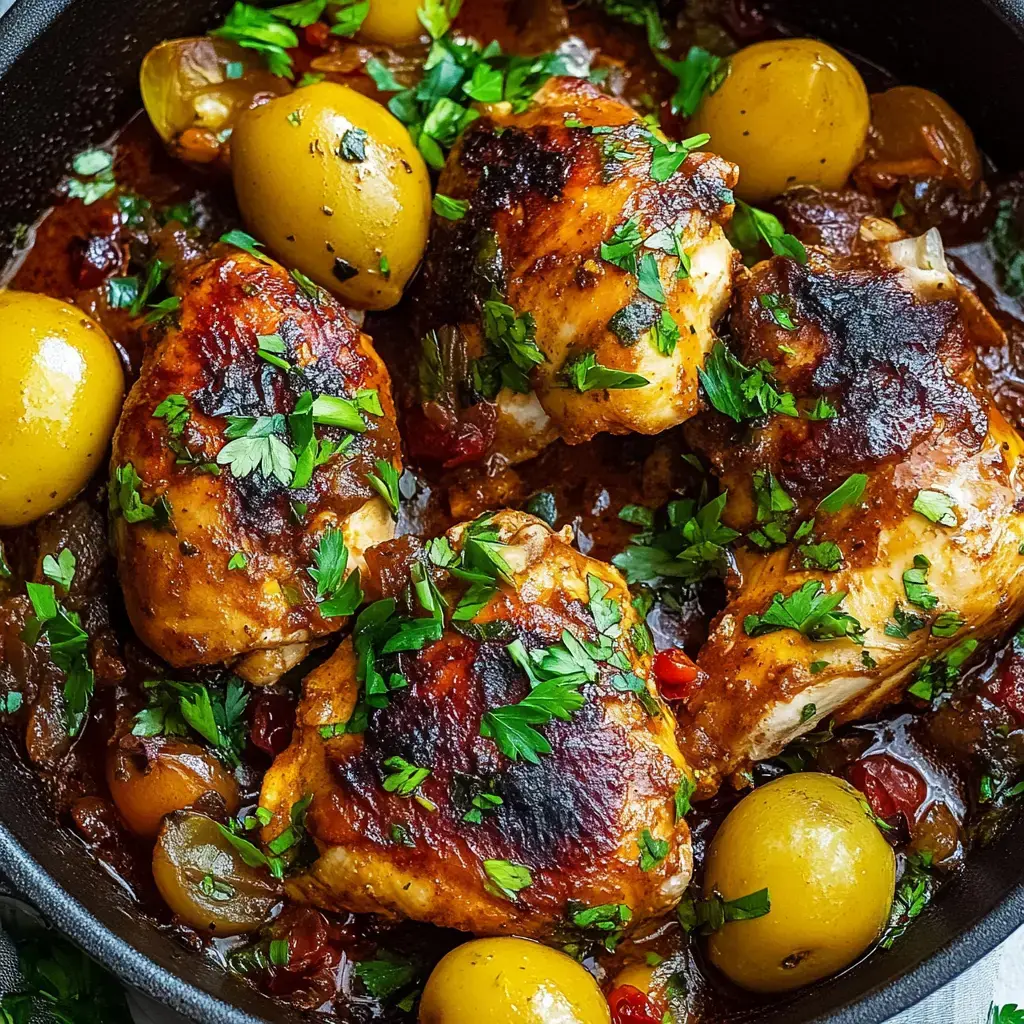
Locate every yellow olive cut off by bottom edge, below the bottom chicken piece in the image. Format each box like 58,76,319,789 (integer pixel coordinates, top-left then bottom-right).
420,938,610,1024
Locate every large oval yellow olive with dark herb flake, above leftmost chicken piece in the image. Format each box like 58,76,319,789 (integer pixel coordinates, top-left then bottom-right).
231,82,431,309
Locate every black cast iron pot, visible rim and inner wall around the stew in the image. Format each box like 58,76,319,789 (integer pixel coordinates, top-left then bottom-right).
0,0,1024,1024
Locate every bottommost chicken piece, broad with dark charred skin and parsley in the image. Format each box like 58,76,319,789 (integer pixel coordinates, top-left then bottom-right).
260,512,692,941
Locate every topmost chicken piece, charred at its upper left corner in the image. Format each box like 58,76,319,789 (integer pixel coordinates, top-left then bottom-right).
423,79,737,461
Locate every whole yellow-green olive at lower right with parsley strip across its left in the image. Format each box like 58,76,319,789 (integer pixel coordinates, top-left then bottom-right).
705,772,896,992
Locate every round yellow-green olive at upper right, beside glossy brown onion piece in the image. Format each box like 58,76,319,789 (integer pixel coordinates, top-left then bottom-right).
687,39,870,203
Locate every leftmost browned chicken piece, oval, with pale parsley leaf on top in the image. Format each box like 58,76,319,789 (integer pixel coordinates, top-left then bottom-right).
111,250,398,682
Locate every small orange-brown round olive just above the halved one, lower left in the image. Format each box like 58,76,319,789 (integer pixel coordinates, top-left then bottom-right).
106,737,240,839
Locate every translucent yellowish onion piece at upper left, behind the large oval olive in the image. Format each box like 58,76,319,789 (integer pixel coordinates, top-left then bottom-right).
139,36,291,163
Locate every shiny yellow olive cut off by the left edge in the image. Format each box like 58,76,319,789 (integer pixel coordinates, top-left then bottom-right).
0,291,125,526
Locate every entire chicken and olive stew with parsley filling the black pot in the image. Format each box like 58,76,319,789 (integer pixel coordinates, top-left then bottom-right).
0,0,1024,1024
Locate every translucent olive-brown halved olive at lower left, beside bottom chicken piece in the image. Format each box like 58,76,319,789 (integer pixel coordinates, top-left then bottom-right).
153,811,282,936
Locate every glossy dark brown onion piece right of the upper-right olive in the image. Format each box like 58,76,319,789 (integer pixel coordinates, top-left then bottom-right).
854,85,981,188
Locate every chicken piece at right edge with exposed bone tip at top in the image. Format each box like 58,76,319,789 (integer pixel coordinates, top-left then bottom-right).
679,224,1024,794
